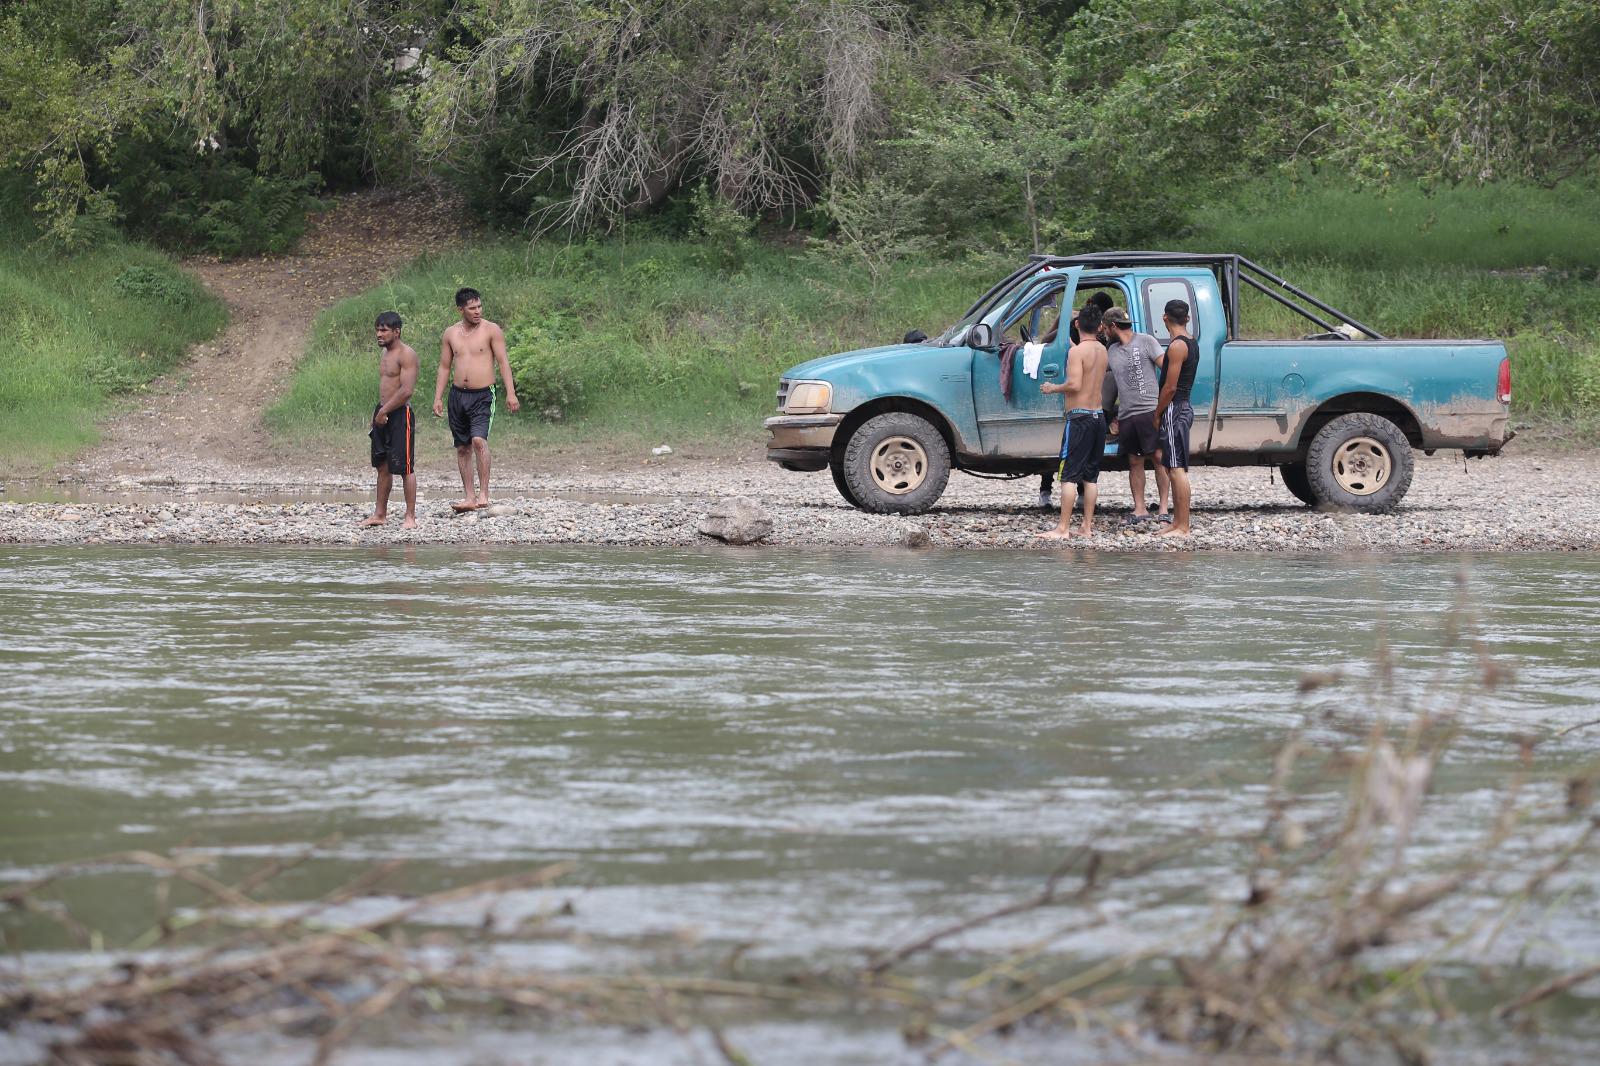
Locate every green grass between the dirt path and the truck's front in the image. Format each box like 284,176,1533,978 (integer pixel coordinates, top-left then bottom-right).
269,240,1005,448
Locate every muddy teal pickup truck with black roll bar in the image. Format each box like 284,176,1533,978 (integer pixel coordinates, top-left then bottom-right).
766,251,1512,514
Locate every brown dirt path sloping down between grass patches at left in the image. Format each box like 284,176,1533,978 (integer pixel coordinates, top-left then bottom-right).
72,192,462,482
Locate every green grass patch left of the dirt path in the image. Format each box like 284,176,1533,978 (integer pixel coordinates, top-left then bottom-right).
0,204,227,475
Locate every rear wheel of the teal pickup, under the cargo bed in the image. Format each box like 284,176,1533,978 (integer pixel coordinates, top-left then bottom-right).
1306,411,1416,514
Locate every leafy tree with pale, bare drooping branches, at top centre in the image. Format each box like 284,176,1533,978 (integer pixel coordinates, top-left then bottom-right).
422,0,906,227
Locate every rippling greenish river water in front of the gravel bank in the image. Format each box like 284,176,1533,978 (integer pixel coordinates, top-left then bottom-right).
0,547,1600,1061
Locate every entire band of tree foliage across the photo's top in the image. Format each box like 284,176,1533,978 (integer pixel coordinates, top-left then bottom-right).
0,0,1600,251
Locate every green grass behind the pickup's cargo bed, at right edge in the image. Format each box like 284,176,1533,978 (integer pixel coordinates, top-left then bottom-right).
1182,178,1600,422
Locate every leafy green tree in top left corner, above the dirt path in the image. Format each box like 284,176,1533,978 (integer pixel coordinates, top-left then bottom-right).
0,0,426,243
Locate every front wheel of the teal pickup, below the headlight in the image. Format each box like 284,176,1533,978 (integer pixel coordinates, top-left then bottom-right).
842,411,950,514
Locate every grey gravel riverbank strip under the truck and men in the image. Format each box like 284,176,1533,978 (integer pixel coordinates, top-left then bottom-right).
0,453,1600,552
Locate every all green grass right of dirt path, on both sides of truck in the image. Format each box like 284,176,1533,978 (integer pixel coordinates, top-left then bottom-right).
270,182,1600,450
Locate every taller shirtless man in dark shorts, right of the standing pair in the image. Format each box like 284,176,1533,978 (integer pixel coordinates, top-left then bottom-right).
434,288,522,512
